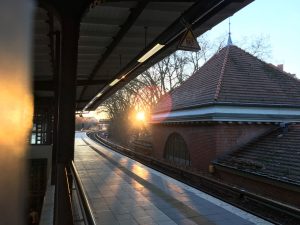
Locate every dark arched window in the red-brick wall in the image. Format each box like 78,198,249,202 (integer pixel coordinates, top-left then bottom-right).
164,133,191,166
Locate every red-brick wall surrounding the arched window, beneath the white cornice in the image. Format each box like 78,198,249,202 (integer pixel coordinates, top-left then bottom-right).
152,123,271,172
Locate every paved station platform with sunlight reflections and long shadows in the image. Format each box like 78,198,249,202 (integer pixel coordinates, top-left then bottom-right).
75,133,271,225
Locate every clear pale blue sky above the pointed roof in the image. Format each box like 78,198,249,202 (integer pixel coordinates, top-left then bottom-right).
208,0,300,78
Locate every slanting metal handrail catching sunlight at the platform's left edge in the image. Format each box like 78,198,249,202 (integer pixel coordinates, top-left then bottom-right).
70,161,96,225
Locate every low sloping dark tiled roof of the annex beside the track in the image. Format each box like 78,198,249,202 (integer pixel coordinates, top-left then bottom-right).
214,124,300,185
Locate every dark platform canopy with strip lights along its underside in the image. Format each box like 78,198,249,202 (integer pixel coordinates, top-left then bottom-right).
33,0,252,110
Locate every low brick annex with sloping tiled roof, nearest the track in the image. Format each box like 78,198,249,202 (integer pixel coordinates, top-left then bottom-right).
213,124,300,207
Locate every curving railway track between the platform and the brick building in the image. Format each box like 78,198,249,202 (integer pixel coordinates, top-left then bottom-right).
87,132,300,225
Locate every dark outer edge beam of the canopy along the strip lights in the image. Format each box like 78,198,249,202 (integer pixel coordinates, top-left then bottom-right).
87,0,253,110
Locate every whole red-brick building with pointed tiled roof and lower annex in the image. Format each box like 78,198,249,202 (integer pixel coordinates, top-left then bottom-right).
152,45,300,207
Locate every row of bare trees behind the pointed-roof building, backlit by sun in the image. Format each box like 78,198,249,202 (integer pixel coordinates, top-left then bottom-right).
96,35,271,143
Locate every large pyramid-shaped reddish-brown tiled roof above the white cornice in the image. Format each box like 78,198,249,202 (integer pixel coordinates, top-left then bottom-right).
153,45,300,113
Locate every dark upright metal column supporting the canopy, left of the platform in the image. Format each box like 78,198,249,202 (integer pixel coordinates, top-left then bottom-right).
55,13,79,225
